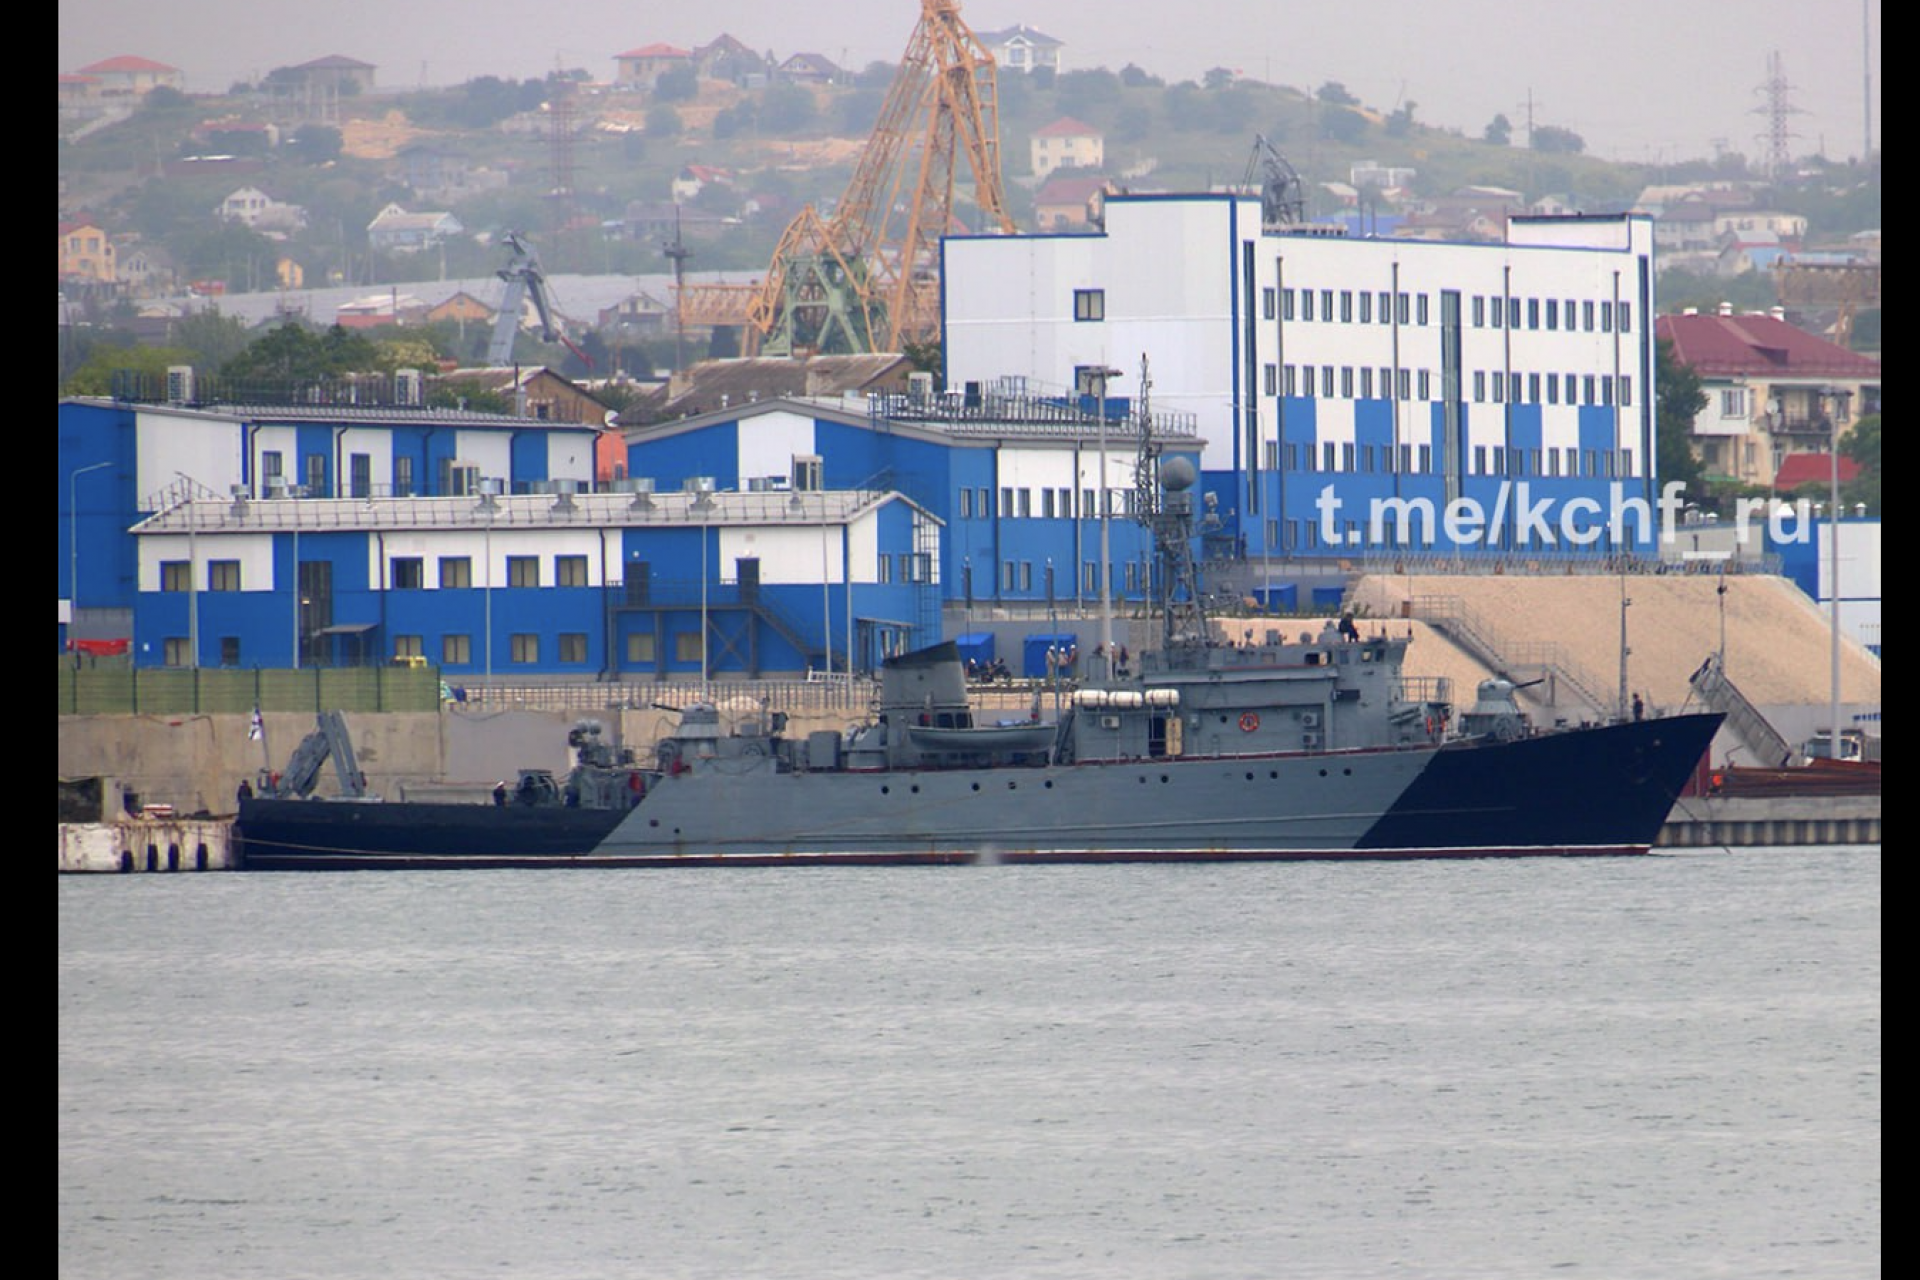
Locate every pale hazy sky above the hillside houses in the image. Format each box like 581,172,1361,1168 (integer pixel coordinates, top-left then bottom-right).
60,0,1880,161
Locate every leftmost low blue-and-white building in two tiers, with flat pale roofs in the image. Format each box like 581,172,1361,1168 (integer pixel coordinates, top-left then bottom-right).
60,383,941,681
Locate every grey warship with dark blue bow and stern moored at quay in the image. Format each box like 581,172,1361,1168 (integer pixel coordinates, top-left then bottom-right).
236,457,1722,869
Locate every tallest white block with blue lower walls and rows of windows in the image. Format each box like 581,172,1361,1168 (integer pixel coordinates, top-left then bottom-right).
943,194,1659,562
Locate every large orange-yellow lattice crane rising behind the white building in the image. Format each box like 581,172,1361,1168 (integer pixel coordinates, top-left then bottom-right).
749,0,1014,355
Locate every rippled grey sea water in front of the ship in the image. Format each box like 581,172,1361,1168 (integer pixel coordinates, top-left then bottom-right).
58,848,1882,1280
